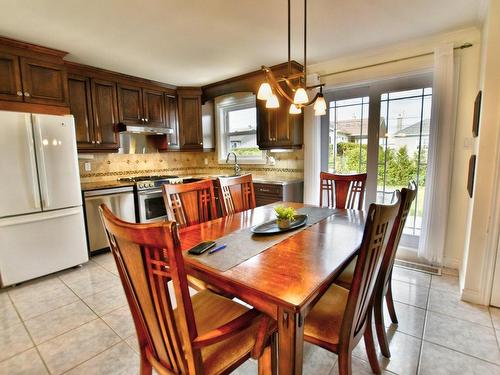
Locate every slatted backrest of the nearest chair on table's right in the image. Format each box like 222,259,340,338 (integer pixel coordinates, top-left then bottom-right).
341,192,400,342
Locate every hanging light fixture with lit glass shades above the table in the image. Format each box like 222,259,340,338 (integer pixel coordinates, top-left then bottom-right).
257,0,327,116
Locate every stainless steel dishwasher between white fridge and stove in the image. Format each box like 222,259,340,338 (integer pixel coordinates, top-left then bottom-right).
83,186,136,253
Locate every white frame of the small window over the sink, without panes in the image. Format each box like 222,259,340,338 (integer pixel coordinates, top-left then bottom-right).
214,92,266,164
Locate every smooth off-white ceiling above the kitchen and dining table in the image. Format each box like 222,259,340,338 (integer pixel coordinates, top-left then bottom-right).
0,0,483,86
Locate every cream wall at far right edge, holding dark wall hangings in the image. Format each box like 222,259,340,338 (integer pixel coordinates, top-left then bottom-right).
461,0,500,304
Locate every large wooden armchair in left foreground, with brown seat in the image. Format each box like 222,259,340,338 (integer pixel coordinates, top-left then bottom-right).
100,204,274,375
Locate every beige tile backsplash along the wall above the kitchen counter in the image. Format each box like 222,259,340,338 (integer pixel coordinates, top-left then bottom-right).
79,150,304,182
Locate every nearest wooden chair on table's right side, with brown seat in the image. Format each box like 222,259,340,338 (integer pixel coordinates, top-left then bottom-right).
304,195,399,375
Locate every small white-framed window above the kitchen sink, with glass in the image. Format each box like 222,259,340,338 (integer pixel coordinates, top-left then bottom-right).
215,93,266,164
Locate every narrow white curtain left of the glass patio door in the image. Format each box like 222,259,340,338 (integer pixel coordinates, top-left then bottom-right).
304,75,321,205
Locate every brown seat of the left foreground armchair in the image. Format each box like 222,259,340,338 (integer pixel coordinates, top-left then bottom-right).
186,290,258,374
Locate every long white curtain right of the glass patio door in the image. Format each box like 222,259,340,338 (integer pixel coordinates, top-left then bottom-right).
418,44,459,266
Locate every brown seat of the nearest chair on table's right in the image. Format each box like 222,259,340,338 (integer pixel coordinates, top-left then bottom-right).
304,284,349,351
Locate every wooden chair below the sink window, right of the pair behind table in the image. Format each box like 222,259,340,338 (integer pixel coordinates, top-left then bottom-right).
217,174,256,216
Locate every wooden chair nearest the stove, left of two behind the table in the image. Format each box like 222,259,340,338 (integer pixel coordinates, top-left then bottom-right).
162,179,217,228
